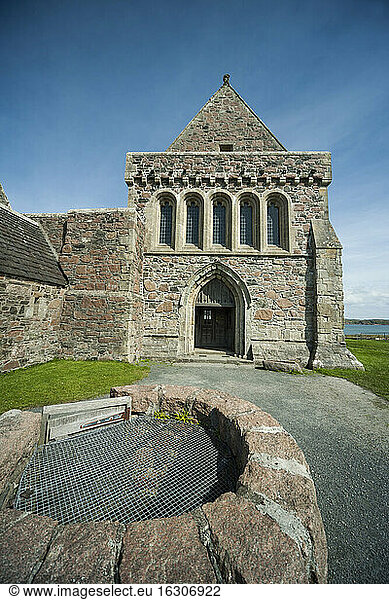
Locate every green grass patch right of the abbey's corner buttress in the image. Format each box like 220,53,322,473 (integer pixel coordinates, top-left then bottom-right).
318,339,389,400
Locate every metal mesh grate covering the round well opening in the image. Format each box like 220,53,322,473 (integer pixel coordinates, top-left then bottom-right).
15,416,235,523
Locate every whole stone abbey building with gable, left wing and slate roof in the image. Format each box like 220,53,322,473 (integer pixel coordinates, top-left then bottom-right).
0,75,360,370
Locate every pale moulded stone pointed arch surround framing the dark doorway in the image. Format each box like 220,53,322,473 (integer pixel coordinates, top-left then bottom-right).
178,262,251,357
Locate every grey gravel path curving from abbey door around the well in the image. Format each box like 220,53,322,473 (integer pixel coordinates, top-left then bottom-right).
142,363,389,583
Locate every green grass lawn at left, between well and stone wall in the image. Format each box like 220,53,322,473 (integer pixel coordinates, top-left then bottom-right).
0,360,149,413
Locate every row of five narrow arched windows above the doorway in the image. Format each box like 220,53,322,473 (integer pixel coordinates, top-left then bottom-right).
156,193,289,250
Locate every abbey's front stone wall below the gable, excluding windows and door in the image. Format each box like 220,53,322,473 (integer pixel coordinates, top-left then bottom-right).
125,147,356,367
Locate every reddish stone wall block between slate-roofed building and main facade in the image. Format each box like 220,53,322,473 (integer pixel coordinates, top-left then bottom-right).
30,208,144,361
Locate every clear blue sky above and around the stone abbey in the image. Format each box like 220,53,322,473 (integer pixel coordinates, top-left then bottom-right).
0,0,389,318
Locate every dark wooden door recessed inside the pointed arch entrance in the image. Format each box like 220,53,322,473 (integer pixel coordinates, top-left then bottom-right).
195,277,235,352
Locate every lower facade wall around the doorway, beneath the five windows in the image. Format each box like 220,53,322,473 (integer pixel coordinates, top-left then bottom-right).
143,254,314,366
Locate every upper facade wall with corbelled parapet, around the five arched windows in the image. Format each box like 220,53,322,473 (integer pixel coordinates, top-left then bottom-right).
125,152,331,254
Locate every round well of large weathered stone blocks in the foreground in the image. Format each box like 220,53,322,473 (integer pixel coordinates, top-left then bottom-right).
0,385,327,583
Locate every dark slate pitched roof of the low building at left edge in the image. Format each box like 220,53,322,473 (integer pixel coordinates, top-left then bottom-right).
0,205,66,286
